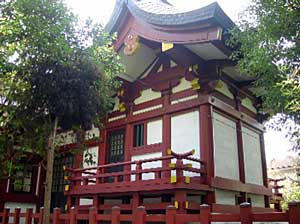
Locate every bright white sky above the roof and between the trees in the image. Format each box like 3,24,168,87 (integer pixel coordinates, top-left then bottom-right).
65,0,296,160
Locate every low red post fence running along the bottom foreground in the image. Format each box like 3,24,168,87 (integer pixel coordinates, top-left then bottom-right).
0,202,300,224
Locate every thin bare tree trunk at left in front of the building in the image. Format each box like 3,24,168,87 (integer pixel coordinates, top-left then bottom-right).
44,118,58,224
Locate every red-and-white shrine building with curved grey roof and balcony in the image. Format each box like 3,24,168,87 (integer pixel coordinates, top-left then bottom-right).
2,0,271,213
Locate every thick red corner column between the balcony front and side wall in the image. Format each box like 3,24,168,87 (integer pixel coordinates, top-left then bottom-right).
200,104,216,205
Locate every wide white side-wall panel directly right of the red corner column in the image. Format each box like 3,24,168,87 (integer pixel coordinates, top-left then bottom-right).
213,112,240,180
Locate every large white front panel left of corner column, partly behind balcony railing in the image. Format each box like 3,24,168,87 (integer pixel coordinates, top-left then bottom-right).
171,111,200,176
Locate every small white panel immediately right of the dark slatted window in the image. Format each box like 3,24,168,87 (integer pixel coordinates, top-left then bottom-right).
147,119,162,145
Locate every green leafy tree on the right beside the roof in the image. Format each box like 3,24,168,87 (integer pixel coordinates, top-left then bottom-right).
228,0,300,149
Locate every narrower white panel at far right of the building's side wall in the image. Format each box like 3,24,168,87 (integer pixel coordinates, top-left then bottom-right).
242,127,263,185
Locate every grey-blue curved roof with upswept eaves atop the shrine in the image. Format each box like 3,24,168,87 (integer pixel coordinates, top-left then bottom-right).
105,0,234,32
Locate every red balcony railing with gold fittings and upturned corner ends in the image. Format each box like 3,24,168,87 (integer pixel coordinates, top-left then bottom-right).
66,150,206,194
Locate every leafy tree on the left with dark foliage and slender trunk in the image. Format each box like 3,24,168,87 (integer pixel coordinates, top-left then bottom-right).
0,0,123,223
